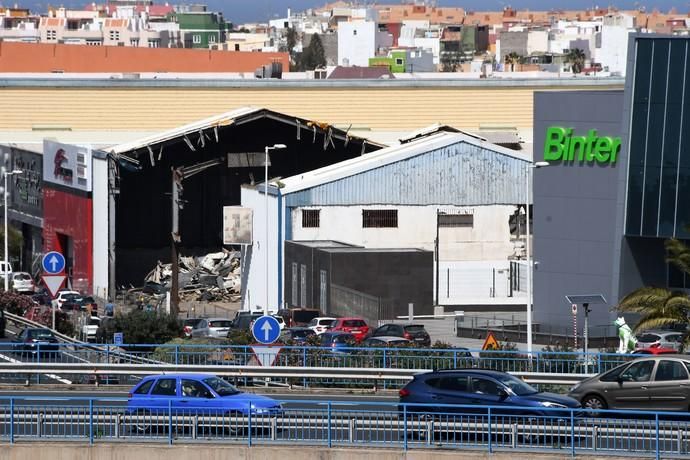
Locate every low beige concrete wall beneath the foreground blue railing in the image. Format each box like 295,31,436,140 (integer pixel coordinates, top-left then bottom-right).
0,442,621,460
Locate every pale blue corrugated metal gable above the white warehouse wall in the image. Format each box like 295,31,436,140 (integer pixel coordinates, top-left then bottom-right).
285,142,528,207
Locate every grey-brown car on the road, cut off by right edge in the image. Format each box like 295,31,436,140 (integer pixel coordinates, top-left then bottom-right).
570,355,690,411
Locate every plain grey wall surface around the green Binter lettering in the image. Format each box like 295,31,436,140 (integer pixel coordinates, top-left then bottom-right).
533,91,623,333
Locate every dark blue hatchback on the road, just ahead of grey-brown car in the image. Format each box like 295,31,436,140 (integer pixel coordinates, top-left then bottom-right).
398,369,580,416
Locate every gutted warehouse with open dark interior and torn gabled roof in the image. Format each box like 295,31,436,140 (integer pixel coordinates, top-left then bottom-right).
44,108,382,297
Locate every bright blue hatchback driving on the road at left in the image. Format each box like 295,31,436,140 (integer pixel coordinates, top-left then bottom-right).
127,374,283,431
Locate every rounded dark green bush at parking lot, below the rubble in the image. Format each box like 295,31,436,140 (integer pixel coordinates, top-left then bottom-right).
100,310,182,344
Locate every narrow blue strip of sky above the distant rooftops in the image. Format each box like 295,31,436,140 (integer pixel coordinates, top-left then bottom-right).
13,0,690,24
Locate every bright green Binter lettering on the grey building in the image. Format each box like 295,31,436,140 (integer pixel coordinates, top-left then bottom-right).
544,126,621,164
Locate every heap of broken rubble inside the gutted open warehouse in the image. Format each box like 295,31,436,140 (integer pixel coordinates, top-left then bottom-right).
144,249,241,302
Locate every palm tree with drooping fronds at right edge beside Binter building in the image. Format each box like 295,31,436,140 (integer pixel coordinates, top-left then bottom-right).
617,239,690,332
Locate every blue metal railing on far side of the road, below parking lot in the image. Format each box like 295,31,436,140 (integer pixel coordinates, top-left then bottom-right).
0,343,640,374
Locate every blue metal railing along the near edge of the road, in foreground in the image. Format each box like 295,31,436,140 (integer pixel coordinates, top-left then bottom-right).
0,397,690,459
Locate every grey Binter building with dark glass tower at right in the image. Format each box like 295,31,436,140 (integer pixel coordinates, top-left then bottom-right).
534,34,690,336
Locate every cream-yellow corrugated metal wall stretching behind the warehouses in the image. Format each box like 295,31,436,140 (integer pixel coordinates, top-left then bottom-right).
0,81,621,131
